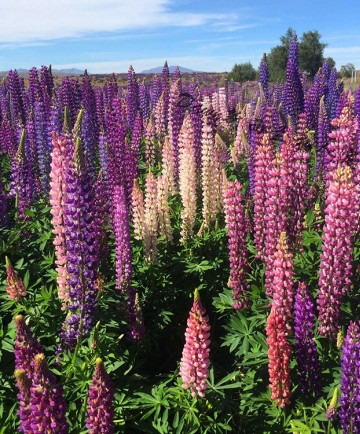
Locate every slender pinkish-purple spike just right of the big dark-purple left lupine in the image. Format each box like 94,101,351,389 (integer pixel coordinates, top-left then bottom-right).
113,185,132,294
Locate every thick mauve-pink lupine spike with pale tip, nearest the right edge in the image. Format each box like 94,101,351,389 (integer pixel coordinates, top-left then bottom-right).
317,167,358,340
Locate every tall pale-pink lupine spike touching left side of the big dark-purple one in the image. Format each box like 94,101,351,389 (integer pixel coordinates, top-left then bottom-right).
50,132,74,303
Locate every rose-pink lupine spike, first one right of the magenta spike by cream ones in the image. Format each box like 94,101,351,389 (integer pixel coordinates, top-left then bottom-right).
254,134,275,260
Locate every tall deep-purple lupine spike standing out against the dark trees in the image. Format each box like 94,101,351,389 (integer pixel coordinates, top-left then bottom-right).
282,36,304,125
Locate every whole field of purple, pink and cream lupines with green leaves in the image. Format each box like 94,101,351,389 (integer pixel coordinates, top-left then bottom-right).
0,38,360,434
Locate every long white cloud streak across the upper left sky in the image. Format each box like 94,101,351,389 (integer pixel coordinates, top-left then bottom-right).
0,0,239,43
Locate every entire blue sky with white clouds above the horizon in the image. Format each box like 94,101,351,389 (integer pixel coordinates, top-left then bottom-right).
0,0,360,73
